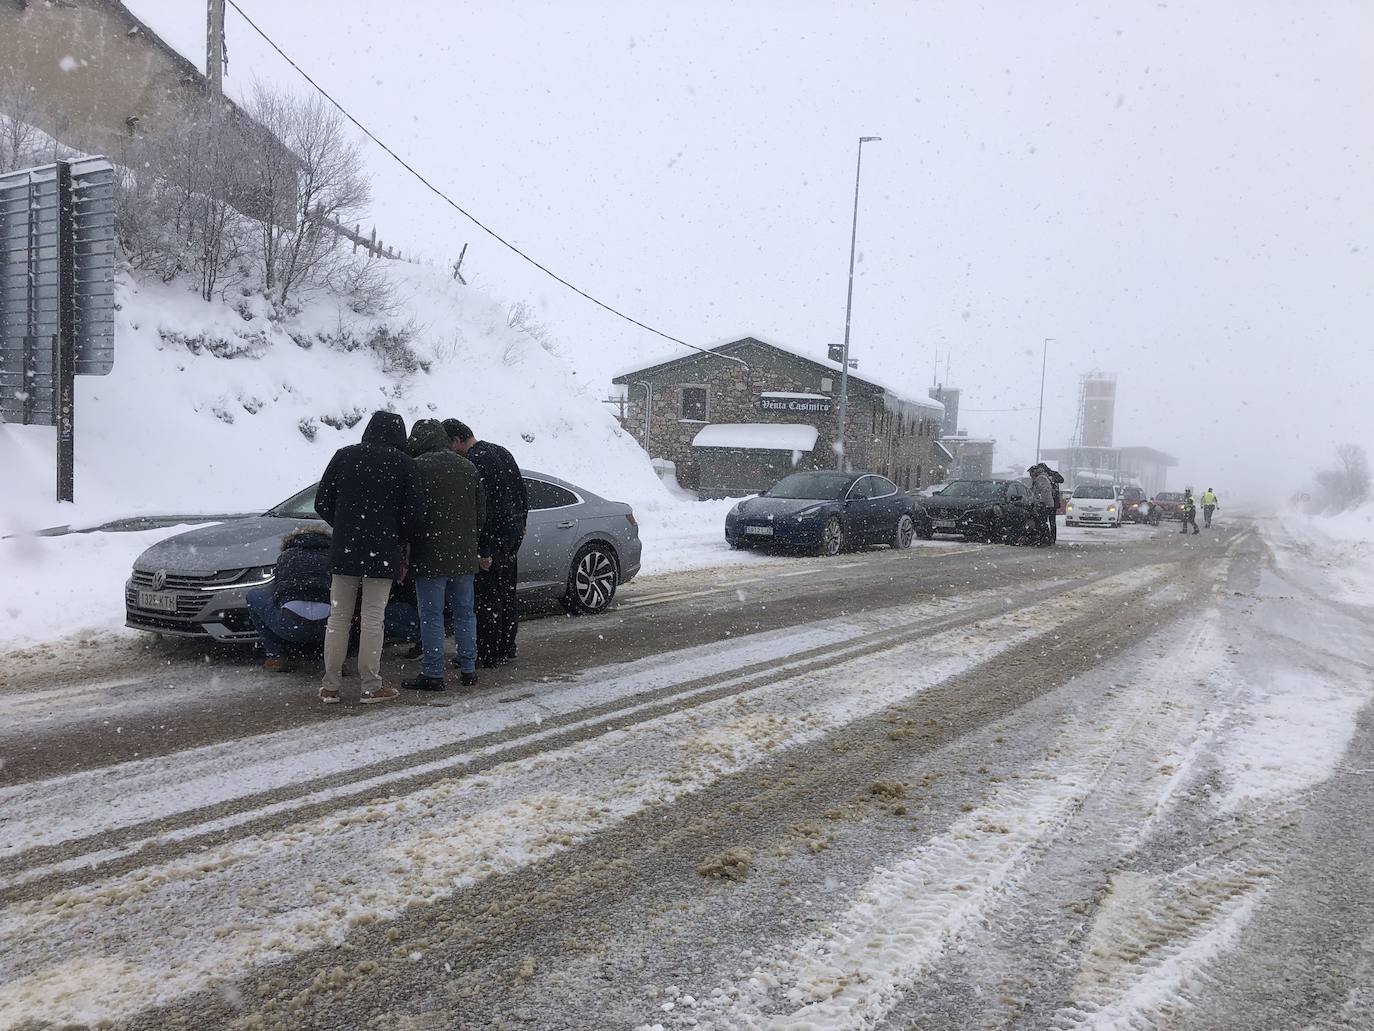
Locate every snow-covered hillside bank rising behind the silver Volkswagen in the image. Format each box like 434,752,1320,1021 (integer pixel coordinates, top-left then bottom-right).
0,263,676,532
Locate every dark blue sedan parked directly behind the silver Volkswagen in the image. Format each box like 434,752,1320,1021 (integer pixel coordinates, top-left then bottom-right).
725,472,930,555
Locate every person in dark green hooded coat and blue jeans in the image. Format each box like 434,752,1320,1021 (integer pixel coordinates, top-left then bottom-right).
401,419,486,691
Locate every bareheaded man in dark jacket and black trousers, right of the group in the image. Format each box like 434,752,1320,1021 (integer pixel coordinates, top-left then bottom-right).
444,419,529,667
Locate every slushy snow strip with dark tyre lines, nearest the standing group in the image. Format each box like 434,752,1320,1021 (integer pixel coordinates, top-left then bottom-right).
0,583,1081,900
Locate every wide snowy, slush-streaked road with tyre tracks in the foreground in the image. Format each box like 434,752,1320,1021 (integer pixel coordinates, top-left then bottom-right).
0,524,1374,1028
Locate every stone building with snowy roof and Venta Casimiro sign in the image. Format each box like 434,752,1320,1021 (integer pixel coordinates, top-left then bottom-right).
614,337,951,498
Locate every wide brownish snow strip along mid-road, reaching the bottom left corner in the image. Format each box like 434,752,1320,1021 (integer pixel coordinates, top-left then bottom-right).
0,566,1167,1027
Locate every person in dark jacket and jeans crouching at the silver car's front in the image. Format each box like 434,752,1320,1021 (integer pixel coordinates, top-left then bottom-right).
246,526,333,674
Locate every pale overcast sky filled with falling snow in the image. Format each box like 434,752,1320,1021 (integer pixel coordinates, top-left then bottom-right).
128,0,1374,496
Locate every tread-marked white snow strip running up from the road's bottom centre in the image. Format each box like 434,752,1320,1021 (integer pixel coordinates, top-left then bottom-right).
646,618,1225,1031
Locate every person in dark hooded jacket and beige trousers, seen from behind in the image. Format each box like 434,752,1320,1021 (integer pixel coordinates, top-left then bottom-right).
315,411,423,705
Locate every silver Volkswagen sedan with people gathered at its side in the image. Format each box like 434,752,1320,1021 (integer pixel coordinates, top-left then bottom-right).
124,470,642,642
